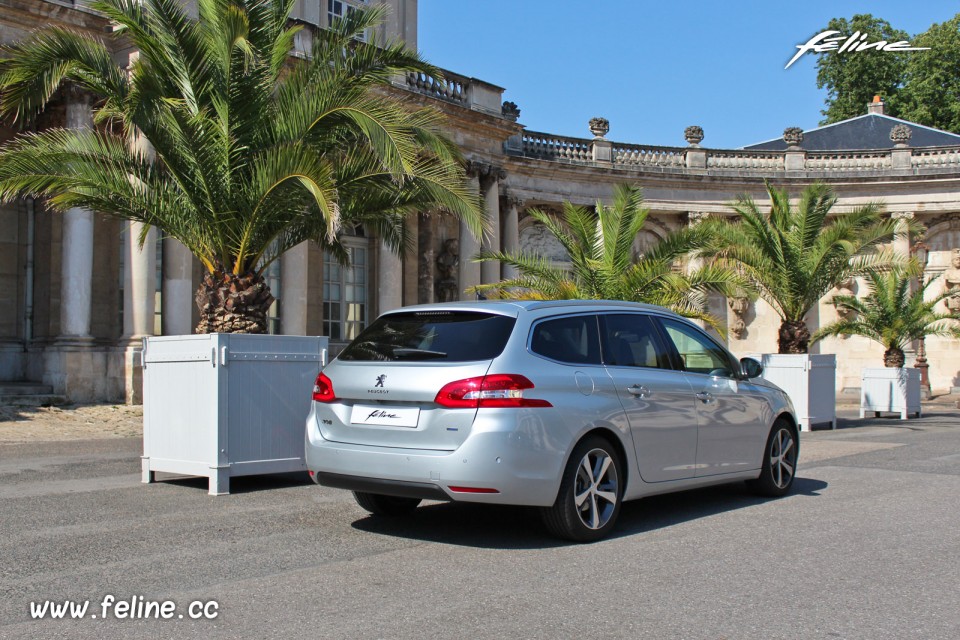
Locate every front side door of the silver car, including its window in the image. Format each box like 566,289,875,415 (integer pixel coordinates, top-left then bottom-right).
658,317,770,476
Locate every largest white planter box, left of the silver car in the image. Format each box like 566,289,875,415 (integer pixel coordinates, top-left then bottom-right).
142,333,328,495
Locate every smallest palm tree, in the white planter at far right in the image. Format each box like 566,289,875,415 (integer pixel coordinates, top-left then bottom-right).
813,262,960,367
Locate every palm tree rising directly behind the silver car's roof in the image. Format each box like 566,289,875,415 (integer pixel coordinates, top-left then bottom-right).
470,185,744,330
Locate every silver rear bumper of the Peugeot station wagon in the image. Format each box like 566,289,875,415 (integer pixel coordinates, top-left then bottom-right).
305,411,566,507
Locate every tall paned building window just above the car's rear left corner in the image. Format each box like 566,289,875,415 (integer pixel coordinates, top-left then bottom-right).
323,238,370,342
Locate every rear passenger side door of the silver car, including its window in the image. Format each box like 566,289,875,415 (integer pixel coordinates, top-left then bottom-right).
600,313,698,482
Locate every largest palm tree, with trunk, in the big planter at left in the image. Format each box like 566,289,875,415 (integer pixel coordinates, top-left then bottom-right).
0,0,483,333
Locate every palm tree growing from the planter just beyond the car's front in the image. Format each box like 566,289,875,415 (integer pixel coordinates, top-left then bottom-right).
703,183,895,353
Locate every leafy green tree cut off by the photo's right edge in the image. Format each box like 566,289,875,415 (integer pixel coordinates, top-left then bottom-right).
895,14,960,133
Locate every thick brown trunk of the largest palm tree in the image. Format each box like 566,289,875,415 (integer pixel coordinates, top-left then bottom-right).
196,271,274,333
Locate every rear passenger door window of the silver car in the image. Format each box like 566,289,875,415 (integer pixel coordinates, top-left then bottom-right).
601,313,671,369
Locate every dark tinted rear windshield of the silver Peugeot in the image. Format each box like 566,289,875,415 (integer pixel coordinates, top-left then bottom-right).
338,311,515,362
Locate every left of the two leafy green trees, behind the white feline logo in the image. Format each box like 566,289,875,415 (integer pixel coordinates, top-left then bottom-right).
817,13,920,124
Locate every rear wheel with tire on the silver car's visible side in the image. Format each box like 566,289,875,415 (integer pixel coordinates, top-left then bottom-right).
541,436,626,542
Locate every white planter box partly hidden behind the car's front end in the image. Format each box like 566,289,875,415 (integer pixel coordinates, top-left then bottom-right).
753,353,837,431
